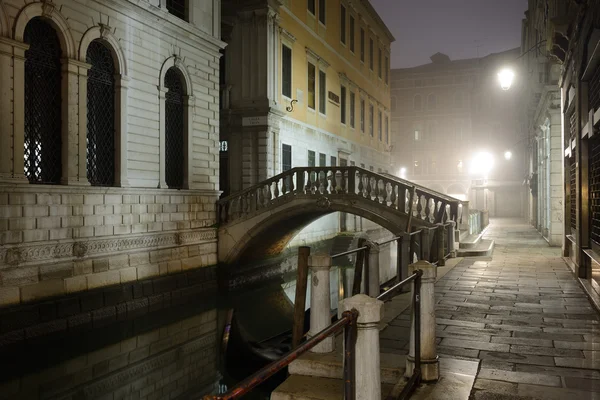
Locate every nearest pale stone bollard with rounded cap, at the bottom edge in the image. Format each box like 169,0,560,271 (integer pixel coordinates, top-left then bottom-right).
341,294,383,400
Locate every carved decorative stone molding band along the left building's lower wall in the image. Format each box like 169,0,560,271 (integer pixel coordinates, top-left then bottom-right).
0,228,217,266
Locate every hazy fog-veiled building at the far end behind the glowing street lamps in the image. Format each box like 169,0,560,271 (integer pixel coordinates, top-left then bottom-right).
391,49,525,216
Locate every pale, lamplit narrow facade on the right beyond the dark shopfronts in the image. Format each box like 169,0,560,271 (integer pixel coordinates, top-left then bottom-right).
519,0,566,246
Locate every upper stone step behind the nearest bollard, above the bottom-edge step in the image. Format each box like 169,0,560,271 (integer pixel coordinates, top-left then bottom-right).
288,346,406,385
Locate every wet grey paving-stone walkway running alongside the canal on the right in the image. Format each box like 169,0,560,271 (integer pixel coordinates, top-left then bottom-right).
381,220,600,400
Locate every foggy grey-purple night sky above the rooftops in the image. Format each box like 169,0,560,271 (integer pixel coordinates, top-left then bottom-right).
370,0,527,68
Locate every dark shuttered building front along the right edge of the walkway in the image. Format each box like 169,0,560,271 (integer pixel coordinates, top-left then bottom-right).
548,1,600,293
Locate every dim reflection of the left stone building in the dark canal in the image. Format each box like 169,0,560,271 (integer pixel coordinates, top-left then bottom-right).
0,299,221,400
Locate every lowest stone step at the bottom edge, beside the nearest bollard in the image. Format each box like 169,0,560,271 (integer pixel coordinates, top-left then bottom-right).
271,375,394,400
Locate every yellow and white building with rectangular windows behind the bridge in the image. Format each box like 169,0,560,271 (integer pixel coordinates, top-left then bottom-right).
221,0,393,247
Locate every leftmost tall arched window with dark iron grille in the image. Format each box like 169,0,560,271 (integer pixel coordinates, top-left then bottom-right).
23,17,62,184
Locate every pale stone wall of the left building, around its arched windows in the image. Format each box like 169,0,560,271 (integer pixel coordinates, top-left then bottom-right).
0,0,224,307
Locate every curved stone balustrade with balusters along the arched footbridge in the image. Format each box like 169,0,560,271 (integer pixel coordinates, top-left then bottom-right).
217,167,460,228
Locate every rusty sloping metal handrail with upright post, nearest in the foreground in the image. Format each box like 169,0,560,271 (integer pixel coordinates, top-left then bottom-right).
204,309,358,400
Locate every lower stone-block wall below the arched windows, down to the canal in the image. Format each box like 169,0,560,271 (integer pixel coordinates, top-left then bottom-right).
0,186,217,305
